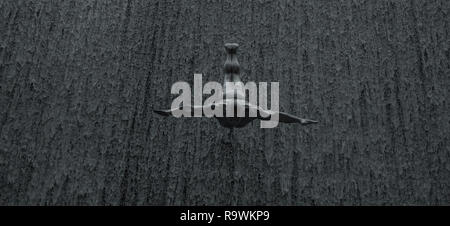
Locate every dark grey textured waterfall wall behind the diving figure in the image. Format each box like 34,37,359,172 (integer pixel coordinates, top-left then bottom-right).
0,0,450,205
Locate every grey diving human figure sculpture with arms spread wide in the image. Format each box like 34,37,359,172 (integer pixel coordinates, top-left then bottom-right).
154,43,317,128
